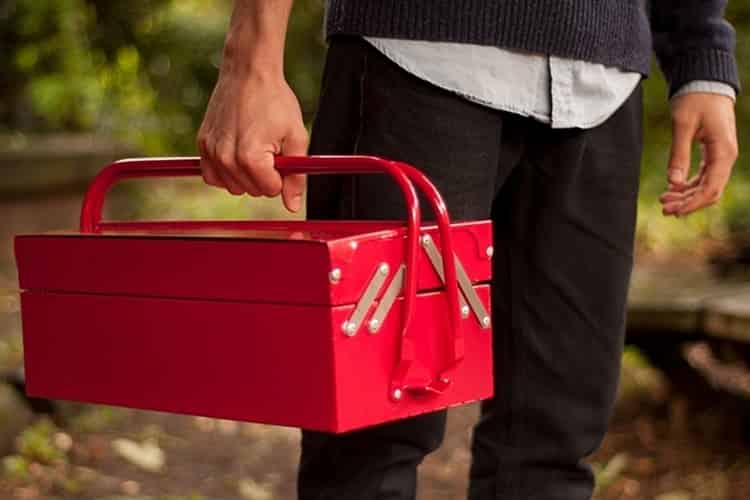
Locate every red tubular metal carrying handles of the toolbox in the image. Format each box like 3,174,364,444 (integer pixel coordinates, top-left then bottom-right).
80,156,464,399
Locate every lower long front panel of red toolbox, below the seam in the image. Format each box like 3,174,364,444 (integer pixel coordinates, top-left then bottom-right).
22,292,335,430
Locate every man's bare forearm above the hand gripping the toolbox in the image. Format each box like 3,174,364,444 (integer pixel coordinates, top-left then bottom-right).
222,0,294,77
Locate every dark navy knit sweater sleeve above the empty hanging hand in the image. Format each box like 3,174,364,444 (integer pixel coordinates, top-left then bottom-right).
650,0,740,95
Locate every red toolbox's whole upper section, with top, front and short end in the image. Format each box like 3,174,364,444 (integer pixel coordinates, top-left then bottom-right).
15,221,492,306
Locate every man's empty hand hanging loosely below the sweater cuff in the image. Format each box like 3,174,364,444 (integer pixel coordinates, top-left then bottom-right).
659,93,738,217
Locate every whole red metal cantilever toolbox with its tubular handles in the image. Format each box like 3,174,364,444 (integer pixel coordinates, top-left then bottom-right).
15,157,493,432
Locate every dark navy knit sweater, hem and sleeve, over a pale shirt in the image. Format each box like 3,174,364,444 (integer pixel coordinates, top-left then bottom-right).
326,0,739,92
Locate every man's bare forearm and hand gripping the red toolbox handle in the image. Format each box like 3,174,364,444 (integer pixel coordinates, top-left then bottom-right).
198,0,308,212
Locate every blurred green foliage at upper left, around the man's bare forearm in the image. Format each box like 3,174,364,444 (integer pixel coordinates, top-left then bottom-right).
0,0,325,154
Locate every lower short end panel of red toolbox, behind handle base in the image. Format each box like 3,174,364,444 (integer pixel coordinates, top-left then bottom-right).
334,285,502,432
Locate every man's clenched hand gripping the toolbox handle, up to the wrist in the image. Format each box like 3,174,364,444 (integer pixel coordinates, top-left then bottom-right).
198,68,308,212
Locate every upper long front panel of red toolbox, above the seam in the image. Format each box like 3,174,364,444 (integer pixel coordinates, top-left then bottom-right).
16,235,330,304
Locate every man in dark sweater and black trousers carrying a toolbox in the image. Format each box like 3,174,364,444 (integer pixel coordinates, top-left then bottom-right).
198,0,739,500
